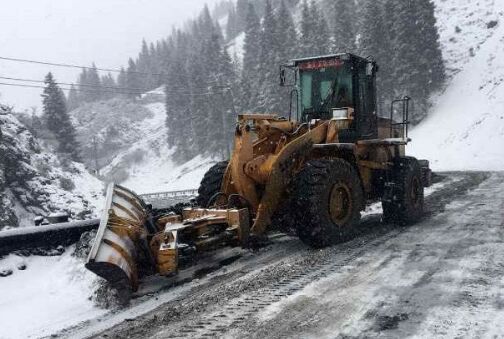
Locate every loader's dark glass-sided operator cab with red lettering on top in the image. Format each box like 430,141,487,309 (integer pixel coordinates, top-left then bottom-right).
280,53,378,142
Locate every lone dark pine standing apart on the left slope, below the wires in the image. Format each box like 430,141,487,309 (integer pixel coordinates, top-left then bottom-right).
42,73,80,161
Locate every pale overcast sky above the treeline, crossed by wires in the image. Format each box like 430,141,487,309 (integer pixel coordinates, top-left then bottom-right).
0,0,218,110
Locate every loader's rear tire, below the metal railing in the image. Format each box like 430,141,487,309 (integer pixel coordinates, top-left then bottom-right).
382,157,424,225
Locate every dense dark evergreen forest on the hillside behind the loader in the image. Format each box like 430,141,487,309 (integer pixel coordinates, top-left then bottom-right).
68,0,445,161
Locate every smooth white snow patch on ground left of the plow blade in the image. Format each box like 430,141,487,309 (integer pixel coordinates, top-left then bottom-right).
0,246,107,339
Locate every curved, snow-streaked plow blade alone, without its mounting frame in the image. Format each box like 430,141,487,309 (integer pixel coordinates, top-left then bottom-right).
86,184,152,290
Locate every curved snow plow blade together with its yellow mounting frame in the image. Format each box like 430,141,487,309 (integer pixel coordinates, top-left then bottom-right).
86,184,250,292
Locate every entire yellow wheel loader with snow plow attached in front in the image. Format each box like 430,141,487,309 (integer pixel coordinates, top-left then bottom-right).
86,54,431,291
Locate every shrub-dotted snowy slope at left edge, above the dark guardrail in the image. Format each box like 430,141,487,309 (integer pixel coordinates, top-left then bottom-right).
0,108,103,228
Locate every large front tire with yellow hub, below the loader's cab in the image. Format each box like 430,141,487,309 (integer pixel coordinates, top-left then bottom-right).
294,159,364,248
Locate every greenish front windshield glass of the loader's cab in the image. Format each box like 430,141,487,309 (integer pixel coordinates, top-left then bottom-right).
300,64,353,118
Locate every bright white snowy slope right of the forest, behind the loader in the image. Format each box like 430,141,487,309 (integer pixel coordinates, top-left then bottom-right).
409,0,504,170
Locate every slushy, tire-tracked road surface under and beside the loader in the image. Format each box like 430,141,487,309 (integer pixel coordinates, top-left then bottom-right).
51,173,504,338
